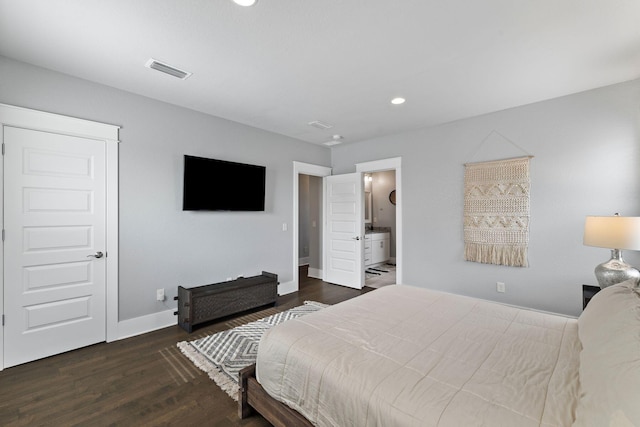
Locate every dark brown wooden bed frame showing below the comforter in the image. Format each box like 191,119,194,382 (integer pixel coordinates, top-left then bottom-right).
238,363,313,427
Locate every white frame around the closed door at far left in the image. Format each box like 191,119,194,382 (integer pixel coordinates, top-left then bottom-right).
0,104,120,370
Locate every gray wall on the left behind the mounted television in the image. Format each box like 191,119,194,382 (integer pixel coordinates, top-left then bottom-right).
0,57,330,320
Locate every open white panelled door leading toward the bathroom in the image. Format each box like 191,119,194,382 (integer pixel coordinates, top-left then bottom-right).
324,172,364,289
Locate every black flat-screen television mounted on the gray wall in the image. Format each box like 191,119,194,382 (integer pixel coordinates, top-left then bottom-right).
182,155,266,211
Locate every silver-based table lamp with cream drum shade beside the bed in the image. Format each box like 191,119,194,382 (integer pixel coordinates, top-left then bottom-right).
583,214,640,288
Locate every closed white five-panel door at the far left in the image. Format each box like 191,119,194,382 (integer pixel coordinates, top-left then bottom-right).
3,126,106,367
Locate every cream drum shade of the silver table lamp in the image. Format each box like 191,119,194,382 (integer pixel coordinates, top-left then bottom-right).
583,216,640,251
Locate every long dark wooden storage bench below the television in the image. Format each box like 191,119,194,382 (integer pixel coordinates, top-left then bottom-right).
176,271,278,333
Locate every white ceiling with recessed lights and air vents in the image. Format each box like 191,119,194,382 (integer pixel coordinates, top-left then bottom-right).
0,0,640,144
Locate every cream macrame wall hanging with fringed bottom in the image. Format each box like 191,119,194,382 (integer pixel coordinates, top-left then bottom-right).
464,132,532,267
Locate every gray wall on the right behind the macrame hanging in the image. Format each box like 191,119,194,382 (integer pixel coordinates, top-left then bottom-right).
332,80,640,315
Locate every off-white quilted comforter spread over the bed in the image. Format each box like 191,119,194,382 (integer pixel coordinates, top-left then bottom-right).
257,285,580,427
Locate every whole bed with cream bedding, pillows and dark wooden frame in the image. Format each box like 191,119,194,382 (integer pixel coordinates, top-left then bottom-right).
239,282,640,427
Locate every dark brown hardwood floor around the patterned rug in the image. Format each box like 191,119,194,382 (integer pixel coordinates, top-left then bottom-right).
0,274,372,427
